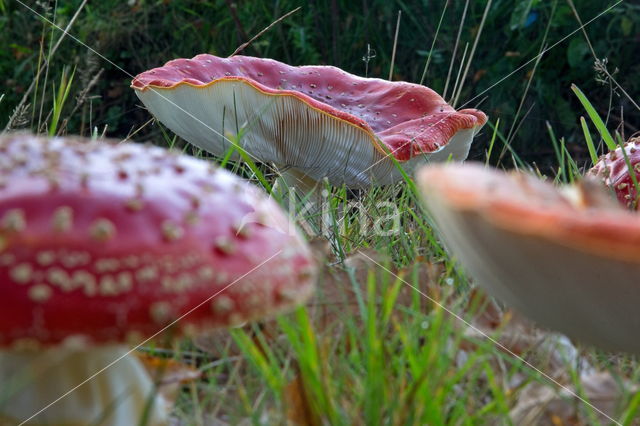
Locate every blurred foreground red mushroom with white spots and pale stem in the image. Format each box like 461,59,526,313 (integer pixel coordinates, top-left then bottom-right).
0,134,314,425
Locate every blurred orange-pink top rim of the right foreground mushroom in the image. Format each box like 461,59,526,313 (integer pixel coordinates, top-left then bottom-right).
417,163,640,263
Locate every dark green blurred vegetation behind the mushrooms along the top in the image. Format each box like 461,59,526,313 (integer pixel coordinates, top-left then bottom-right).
0,0,640,170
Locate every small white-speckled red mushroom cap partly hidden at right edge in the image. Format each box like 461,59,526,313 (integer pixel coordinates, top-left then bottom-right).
588,138,640,210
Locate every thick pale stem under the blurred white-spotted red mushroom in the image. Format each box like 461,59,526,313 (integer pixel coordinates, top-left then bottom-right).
0,345,169,426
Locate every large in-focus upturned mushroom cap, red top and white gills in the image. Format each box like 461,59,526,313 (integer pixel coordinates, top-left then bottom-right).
132,54,487,188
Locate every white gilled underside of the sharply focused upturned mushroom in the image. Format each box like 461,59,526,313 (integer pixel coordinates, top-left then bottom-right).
136,81,479,188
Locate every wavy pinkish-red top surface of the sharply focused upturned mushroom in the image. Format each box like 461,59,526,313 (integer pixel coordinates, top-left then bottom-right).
131,54,487,162
